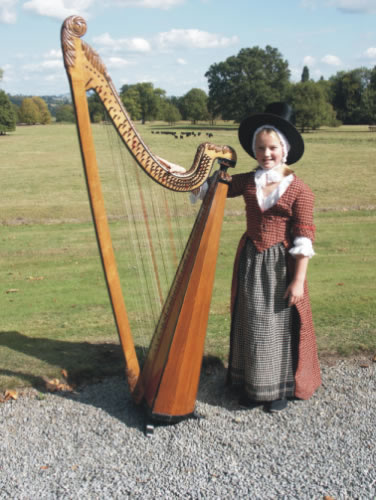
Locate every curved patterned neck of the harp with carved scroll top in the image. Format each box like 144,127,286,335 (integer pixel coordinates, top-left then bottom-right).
61,16,236,191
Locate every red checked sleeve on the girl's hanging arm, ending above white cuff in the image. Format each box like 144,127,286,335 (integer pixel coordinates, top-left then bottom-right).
291,184,315,243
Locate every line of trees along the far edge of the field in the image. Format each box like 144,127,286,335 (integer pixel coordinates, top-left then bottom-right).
0,46,376,133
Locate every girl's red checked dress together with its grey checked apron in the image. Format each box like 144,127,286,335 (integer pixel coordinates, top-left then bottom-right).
228,172,321,401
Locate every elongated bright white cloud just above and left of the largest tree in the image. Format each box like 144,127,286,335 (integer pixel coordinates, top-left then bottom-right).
158,29,239,49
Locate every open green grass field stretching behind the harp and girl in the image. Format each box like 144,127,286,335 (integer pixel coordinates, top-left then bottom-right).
0,124,376,391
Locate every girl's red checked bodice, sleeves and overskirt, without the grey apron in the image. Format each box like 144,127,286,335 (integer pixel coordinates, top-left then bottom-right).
228,172,321,399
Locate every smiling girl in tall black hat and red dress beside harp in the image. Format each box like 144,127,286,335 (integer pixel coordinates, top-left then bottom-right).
228,103,321,412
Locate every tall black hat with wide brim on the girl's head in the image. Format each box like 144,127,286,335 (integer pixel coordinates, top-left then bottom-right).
238,102,304,165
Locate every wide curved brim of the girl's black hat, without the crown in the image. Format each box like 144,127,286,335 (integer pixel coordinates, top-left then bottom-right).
238,113,304,165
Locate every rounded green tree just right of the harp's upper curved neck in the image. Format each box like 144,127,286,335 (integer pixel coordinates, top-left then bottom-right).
120,82,165,123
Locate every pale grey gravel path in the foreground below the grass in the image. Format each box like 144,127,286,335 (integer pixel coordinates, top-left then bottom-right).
0,361,376,500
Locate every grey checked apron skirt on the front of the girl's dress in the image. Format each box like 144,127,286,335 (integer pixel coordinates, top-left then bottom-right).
229,240,299,401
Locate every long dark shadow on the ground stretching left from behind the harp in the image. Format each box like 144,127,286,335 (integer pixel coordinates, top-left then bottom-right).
0,331,229,430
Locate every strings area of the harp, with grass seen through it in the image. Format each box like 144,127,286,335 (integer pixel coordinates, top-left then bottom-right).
95,114,199,356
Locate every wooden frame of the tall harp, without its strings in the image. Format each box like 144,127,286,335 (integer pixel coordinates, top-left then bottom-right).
62,16,236,422
